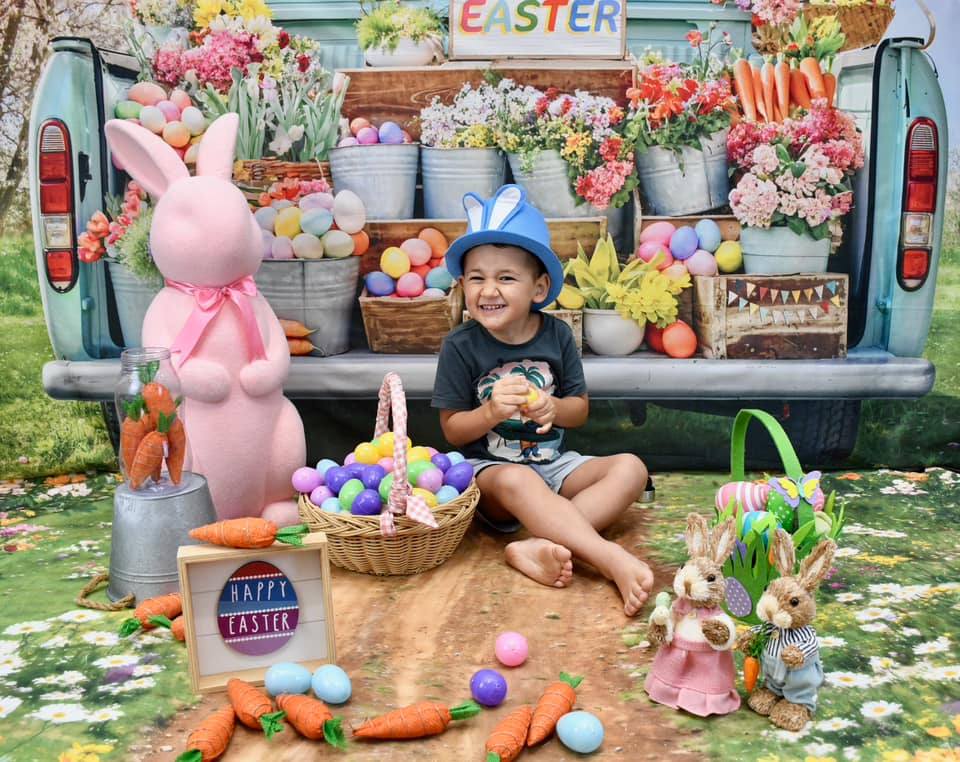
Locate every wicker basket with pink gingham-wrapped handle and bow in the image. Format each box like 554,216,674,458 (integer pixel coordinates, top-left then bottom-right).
300,373,480,575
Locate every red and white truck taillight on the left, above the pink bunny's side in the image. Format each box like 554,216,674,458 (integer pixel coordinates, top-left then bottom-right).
37,119,79,293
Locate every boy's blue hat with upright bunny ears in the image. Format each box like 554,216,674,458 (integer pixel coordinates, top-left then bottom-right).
446,185,563,310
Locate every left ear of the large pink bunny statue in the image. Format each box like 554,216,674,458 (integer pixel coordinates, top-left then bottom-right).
104,119,190,199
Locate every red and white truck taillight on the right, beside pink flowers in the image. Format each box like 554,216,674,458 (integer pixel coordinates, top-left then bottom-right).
897,117,940,291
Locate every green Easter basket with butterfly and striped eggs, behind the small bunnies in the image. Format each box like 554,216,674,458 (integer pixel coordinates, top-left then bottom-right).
716,410,844,625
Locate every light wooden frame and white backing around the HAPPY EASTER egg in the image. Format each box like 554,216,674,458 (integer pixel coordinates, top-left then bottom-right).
177,532,337,693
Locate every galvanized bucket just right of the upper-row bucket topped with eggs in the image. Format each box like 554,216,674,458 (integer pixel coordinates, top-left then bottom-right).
420,146,507,220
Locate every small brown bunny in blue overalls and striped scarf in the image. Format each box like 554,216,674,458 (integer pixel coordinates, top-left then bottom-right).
737,529,837,731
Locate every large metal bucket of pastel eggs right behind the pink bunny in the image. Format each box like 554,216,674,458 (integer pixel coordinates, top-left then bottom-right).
253,257,360,357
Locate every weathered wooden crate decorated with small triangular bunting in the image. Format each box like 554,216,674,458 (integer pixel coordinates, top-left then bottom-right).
693,273,849,360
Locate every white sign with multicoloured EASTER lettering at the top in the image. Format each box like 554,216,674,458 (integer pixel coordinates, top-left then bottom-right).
450,0,626,59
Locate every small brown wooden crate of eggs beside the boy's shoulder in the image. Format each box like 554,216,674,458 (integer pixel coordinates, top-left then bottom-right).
360,283,463,354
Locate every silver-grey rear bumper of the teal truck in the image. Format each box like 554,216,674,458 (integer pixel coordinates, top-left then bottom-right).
43,350,935,401
